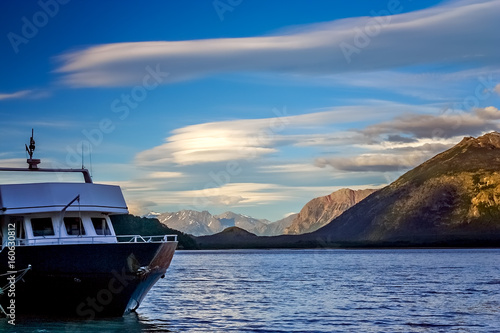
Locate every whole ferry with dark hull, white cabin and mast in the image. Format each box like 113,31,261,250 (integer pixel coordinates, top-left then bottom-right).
0,132,177,320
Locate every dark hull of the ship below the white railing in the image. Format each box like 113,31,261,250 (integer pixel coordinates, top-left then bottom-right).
0,242,177,319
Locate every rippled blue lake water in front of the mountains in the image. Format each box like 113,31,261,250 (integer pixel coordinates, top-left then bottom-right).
0,249,500,333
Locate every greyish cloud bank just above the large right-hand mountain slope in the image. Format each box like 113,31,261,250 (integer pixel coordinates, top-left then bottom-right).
315,106,500,172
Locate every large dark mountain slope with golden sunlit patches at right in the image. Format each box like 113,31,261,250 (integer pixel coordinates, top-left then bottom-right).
313,132,500,244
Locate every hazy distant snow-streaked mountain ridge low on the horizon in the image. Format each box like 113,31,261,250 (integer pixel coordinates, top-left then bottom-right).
143,210,296,236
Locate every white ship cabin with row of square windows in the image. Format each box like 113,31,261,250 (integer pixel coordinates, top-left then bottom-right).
0,168,128,249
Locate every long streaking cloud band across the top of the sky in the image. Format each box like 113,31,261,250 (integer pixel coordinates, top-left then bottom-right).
56,0,500,87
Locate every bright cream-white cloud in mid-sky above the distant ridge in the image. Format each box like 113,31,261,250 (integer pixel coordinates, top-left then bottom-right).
136,110,330,165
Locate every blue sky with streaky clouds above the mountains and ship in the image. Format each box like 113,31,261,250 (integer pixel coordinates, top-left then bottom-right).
0,0,500,221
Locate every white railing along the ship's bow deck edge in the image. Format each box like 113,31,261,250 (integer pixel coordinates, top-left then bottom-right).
8,235,177,246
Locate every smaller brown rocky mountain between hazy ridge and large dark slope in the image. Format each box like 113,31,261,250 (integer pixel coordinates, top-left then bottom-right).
284,188,376,235
